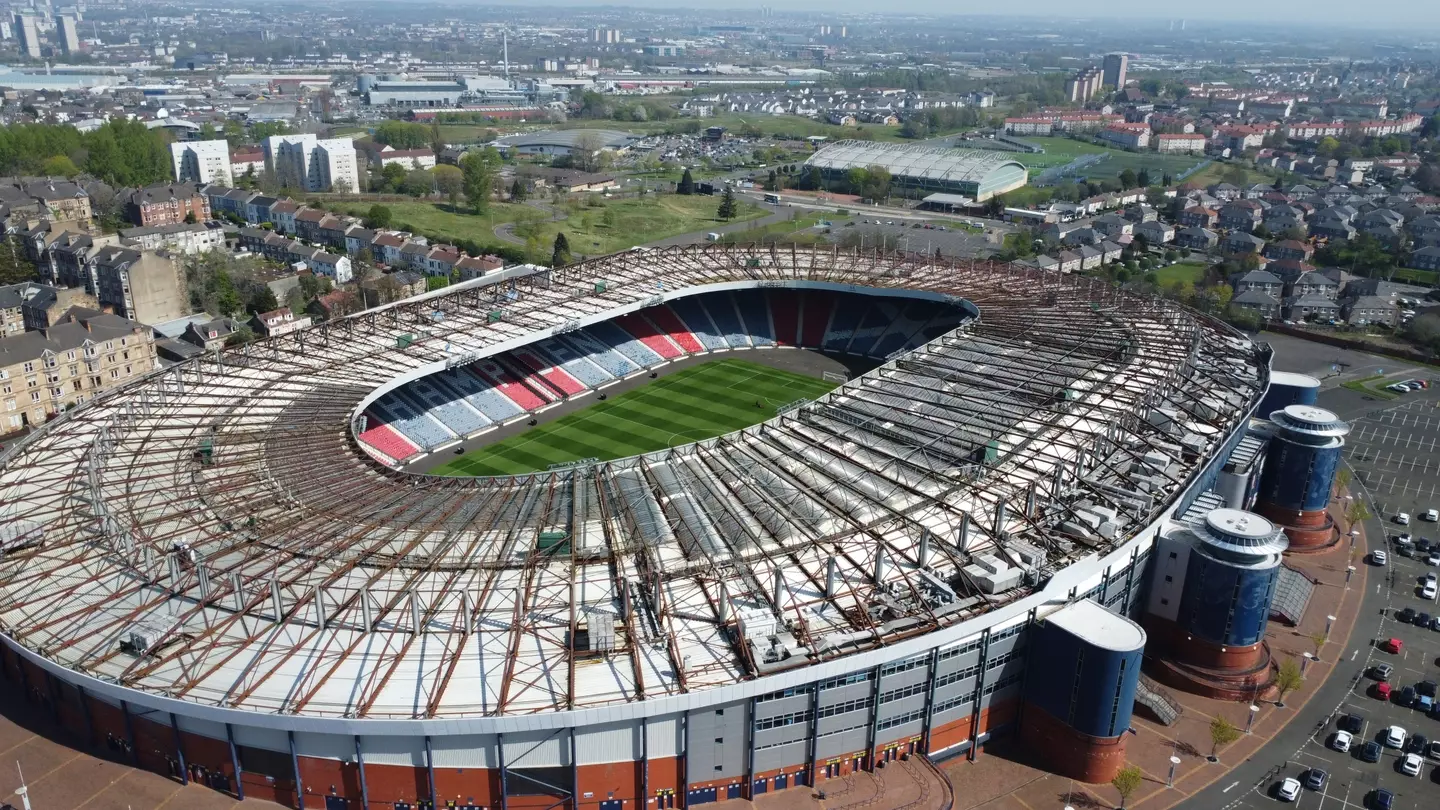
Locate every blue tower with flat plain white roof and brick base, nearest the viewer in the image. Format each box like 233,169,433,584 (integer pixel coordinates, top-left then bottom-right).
1021,600,1145,783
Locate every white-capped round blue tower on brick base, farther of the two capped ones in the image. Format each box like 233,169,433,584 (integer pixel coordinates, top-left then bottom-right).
1256,405,1349,551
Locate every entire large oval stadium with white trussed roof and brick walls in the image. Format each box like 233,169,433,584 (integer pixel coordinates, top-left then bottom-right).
0,245,1301,810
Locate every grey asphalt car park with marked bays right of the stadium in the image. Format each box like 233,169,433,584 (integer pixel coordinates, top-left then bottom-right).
1228,388,1440,810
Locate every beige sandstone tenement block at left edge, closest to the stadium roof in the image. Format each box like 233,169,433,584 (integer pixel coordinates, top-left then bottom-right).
0,307,156,432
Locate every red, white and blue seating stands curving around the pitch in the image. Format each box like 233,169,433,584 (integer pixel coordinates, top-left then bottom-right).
371,290,963,460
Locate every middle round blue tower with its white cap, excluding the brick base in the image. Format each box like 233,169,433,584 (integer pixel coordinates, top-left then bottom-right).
1178,509,1287,647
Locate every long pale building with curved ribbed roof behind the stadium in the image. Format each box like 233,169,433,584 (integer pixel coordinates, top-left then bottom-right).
805,140,1030,203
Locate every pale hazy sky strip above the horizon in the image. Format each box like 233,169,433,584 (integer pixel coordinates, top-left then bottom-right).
481,0,1440,29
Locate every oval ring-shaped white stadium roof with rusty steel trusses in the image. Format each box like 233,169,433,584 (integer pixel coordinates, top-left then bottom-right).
0,246,1267,717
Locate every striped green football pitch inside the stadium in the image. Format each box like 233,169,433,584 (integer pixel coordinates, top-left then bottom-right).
432,359,835,476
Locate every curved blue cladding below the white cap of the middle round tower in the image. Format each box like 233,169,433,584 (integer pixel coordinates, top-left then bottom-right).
1179,553,1280,647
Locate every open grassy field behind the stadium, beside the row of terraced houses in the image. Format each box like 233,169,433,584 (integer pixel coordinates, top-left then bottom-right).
341,195,766,257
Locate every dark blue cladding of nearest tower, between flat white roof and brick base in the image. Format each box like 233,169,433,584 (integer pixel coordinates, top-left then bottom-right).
1025,623,1142,738
